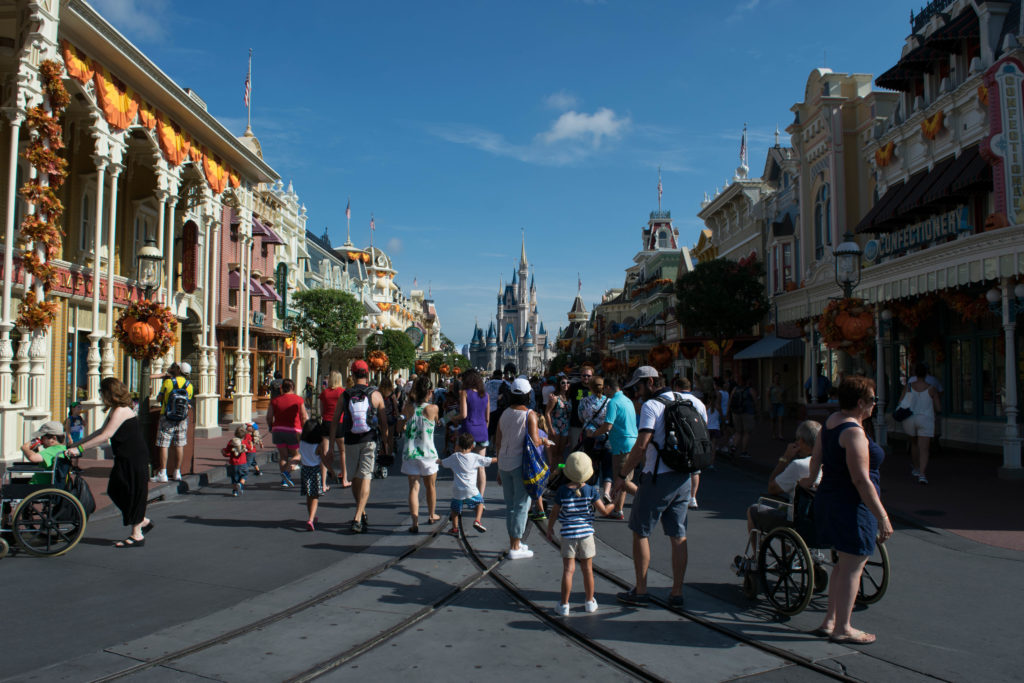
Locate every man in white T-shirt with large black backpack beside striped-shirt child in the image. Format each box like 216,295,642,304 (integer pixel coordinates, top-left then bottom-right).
611,366,712,607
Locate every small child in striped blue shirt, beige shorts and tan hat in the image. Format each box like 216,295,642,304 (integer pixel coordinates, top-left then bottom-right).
548,451,613,616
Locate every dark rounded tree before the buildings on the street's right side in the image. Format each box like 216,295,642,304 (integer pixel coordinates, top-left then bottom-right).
676,258,768,348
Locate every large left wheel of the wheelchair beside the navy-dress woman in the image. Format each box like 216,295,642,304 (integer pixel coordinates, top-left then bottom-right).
758,526,814,616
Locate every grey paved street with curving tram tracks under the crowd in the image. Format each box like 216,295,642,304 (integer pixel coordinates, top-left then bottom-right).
0,446,1024,681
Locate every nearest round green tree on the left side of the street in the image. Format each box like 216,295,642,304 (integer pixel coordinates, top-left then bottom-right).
288,290,364,360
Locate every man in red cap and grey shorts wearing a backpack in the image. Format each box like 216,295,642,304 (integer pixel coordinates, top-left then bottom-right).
321,360,391,533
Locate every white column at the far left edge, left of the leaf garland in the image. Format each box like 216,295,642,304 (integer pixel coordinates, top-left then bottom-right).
0,109,25,458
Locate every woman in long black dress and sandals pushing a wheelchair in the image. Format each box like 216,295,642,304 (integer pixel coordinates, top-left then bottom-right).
69,377,153,548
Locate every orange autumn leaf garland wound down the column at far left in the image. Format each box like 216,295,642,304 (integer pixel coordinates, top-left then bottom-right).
15,59,71,332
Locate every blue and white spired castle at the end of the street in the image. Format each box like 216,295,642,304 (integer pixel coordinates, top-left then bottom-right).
469,233,553,375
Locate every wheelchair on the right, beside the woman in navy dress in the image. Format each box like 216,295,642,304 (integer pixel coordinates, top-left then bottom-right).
733,486,892,616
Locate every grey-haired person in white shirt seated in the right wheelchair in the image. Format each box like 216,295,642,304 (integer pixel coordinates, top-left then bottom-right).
737,420,821,562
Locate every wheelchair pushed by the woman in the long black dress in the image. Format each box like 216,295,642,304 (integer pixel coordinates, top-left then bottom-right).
0,457,88,558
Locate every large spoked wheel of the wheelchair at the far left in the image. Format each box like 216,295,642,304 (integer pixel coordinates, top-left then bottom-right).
11,488,85,557
